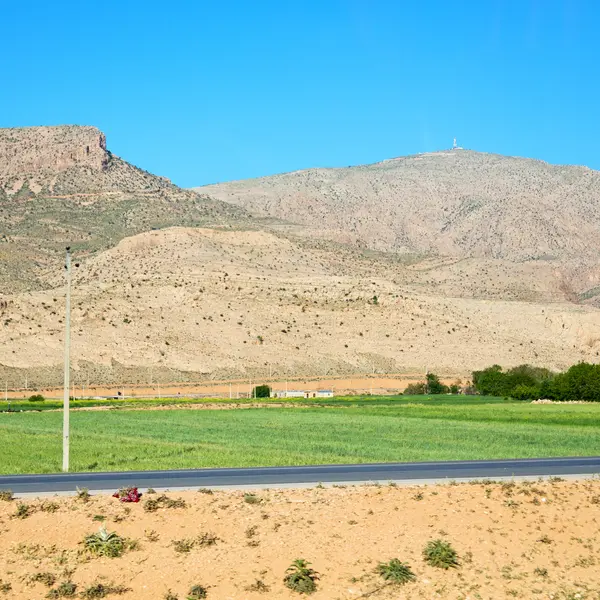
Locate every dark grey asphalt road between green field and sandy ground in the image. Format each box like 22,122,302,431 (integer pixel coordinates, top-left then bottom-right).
0,456,600,494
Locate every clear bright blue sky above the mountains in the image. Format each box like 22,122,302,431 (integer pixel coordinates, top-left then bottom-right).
0,0,600,186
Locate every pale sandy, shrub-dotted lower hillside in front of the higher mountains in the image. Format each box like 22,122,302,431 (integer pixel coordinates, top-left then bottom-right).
0,228,600,386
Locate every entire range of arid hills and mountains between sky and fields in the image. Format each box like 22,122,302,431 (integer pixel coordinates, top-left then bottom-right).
0,127,600,387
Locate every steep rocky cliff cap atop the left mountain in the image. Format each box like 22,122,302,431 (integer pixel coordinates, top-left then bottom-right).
0,125,109,177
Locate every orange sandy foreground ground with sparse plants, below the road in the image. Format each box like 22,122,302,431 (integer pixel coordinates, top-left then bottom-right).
0,479,600,600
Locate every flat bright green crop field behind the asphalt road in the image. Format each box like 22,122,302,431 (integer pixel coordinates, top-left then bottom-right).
0,396,600,473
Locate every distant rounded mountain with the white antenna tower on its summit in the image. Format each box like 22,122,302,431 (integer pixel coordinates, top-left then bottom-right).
195,150,600,262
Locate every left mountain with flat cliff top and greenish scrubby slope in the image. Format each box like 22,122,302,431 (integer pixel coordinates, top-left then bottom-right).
0,126,249,293
